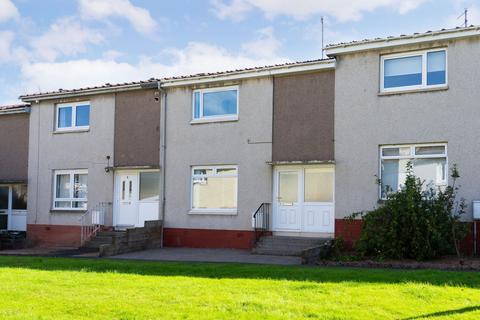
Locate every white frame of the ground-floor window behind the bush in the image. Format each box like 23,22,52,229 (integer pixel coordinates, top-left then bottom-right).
378,143,449,200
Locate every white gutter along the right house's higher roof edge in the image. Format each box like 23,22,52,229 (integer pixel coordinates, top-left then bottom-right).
325,27,480,57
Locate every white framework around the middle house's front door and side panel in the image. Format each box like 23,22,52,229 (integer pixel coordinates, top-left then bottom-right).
272,164,336,234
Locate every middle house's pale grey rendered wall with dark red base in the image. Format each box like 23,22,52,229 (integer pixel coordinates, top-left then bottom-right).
165,78,273,248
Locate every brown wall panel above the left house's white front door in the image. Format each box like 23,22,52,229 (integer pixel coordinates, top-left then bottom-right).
114,90,160,167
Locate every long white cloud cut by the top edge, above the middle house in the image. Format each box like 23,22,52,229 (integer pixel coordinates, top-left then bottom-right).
211,0,427,22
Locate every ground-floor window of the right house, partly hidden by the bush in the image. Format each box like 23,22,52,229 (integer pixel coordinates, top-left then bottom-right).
380,143,448,199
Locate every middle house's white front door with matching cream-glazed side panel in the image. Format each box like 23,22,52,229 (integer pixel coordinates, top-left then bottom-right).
273,165,335,233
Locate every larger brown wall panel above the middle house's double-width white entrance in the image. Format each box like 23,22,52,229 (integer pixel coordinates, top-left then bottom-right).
272,70,335,161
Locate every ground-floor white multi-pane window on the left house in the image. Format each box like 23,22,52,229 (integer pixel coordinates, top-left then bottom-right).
53,170,88,210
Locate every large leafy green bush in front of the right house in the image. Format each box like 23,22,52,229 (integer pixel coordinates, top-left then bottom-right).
352,163,466,260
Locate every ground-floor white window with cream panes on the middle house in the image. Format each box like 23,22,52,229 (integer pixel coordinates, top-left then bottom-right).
190,165,238,214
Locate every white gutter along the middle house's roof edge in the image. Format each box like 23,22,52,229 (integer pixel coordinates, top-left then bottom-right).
161,59,335,88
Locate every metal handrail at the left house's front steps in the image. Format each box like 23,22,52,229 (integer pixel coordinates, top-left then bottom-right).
79,202,112,246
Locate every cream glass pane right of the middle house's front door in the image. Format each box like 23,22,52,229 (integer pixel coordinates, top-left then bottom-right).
305,169,333,202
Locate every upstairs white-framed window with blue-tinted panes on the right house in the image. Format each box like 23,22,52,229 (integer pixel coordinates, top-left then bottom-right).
380,49,448,92
